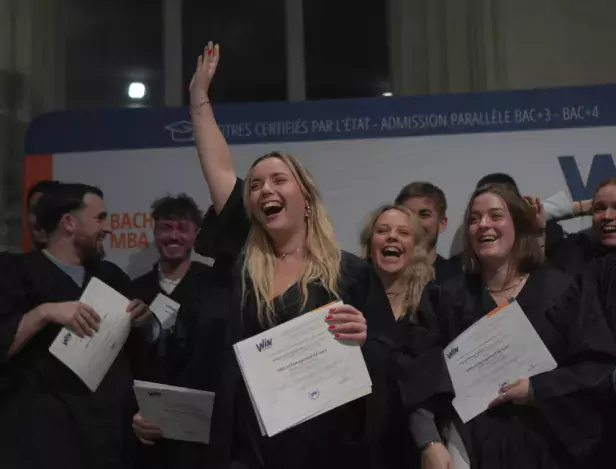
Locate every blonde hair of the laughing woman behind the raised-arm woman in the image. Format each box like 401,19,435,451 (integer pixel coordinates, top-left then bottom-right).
360,204,434,317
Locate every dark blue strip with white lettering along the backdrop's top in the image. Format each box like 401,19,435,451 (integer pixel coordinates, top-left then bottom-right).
26,81,616,155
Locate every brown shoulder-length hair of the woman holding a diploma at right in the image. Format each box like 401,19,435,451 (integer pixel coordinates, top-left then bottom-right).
463,183,544,273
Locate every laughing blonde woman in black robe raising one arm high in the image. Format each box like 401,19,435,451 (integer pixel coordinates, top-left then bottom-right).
190,43,394,469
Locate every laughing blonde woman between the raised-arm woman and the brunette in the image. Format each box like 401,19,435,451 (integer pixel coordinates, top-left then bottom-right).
361,205,453,469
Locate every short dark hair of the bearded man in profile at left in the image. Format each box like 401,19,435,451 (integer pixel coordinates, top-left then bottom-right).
34,183,103,234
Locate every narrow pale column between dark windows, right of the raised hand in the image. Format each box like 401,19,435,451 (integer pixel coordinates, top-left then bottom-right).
285,0,306,101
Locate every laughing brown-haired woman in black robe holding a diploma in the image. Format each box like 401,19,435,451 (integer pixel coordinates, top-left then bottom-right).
418,184,616,469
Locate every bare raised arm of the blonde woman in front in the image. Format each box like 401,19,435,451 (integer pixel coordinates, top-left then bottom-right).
190,41,237,213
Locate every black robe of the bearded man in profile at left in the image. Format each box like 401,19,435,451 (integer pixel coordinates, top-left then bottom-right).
0,252,136,469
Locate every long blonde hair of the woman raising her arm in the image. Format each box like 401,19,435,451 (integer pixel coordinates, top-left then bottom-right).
242,152,342,327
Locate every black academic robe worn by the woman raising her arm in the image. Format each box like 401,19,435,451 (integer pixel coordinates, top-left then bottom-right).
190,179,395,469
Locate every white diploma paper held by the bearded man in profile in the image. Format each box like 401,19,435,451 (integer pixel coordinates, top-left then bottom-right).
49,277,131,392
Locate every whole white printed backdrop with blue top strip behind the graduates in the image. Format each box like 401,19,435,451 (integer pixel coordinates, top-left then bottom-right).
24,85,616,276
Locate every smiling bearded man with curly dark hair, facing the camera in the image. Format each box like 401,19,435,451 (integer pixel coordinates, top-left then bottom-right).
130,194,219,469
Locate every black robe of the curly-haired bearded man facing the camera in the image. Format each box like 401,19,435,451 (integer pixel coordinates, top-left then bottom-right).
130,262,226,469
